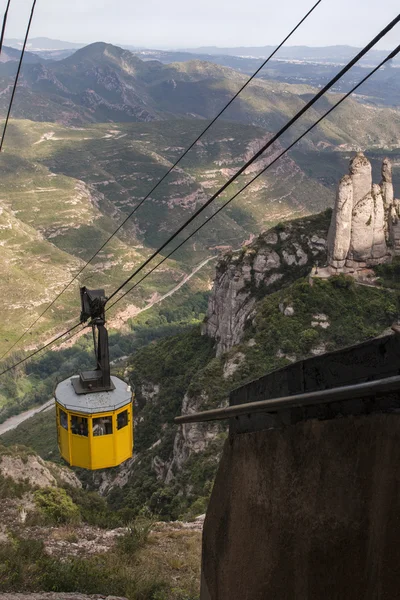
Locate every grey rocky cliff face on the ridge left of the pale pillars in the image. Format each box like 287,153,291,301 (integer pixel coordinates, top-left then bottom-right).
203,211,329,356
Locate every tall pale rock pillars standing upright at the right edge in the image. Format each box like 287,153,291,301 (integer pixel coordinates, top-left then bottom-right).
328,152,399,272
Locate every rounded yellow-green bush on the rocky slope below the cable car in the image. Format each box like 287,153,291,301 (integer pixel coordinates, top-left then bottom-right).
34,488,80,524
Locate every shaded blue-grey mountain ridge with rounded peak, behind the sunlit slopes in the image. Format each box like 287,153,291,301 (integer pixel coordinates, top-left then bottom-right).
0,42,400,136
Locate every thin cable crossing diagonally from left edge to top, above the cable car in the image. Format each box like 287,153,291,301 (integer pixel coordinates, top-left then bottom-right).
0,0,322,360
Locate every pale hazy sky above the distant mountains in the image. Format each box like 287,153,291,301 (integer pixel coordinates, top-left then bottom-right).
0,0,400,48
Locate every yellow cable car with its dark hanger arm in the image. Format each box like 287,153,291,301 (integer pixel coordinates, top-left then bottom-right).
55,288,133,469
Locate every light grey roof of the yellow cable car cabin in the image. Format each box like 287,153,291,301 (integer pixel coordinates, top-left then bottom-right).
55,376,132,415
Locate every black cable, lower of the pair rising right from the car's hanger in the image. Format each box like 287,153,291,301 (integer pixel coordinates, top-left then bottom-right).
107,45,400,311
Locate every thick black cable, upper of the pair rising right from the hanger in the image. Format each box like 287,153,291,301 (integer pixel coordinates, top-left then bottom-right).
108,14,400,300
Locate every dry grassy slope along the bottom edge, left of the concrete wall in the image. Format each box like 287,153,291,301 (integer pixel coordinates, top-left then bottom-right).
0,534,200,600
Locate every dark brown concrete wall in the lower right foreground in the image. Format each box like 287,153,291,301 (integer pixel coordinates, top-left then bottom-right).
201,336,400,600
